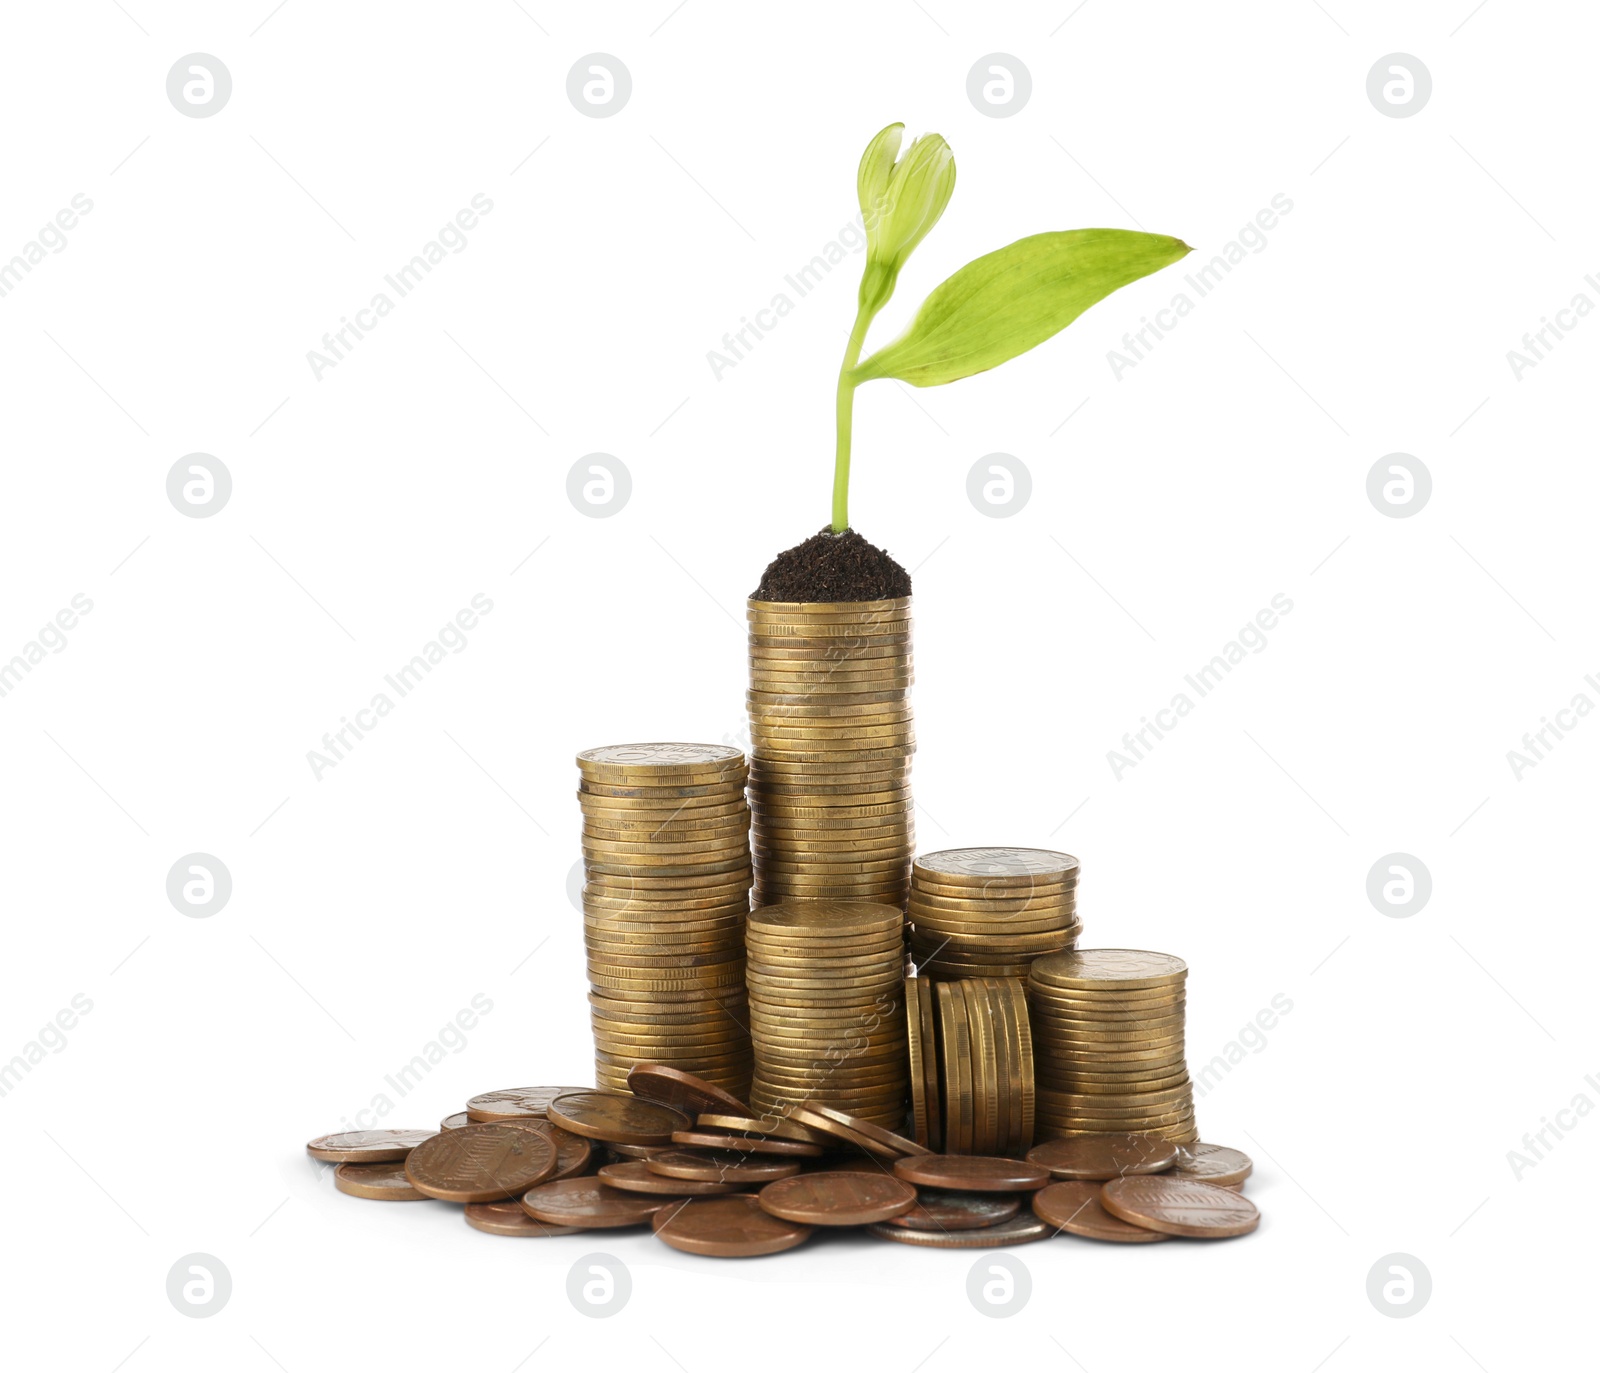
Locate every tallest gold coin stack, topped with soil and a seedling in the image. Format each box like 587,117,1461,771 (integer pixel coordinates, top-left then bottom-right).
746,597,915,906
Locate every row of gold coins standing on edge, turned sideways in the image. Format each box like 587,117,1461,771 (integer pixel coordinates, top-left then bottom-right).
906,978,1034,1154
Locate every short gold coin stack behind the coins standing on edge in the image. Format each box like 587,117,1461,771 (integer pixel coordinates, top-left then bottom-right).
906,848,1083,978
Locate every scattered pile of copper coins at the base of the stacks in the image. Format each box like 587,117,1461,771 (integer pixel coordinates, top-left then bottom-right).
306,1064,1259,1258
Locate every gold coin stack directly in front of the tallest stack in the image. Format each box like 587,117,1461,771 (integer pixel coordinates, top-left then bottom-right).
742,901,909,1130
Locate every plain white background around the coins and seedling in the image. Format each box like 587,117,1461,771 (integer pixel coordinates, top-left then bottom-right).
0,0,1600,1373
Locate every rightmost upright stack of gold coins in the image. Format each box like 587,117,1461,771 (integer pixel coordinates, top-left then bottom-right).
1027,949,1198,1143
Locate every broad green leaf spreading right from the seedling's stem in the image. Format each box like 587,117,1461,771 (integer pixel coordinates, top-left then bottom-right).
850,229,1192,386
